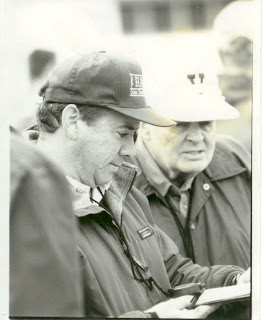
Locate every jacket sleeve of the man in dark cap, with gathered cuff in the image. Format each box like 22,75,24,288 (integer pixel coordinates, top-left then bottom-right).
156,227,244,288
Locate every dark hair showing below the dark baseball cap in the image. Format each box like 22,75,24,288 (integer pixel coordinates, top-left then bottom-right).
36,101,107,133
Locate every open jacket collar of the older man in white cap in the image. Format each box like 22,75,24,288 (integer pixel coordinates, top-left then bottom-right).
134,137,246,197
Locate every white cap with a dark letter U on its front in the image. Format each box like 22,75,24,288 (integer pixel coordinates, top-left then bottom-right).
147,72,239,122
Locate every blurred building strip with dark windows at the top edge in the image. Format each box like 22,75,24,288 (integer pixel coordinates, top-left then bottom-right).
120,0,232,33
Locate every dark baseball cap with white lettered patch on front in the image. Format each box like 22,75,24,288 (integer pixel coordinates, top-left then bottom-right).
39,51,174,127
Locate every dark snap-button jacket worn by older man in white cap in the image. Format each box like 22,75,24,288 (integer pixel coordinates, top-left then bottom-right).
135,136,251,269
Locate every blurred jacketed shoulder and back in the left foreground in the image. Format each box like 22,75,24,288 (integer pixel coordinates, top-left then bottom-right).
9,134,83,318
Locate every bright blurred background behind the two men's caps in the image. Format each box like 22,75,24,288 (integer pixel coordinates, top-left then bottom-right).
1,0,254,149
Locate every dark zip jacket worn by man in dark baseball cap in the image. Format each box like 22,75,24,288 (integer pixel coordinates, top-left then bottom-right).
73,163,242,318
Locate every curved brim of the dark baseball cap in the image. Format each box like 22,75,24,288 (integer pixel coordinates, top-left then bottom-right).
107,105,175,127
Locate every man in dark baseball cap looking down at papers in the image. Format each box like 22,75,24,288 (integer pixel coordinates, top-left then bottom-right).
22,51,249,318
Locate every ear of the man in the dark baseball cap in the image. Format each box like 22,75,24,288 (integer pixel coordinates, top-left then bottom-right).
61,104,80,140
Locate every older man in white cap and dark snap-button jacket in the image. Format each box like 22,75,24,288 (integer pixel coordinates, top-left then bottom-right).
135,72,251,268
